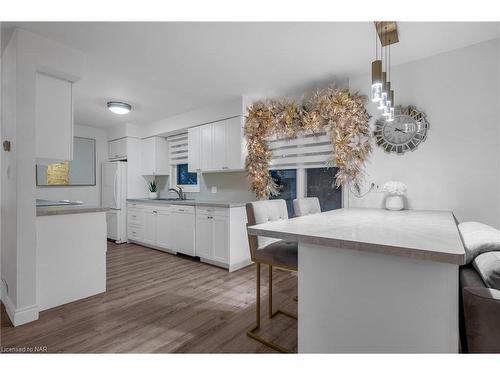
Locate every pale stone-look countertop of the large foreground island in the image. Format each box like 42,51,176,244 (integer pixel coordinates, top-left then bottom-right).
248,208,465,265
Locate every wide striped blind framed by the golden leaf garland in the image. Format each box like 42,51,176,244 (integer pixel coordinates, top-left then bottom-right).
268,132,333,170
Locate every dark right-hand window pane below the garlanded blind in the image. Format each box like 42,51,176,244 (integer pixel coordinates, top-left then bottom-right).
305,168,342,211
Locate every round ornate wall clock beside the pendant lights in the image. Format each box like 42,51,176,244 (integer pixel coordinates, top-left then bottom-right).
373,106,429,154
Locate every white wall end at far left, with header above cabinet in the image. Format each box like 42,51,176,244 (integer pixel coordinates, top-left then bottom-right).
1,29,83,325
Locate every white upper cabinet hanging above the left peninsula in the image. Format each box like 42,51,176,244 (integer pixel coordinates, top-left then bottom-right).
35,73,73,164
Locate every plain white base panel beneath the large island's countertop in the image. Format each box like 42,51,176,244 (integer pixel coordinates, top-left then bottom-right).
298,243,459,353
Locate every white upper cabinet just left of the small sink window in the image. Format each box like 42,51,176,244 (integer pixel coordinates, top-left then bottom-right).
142,137,170,176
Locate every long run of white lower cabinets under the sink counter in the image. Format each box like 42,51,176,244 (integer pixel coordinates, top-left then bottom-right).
127,204,251,271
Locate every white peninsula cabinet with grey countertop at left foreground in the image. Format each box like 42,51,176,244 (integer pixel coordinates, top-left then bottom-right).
36,202,107,311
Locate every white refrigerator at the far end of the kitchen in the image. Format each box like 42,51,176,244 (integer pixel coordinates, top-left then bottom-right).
102,161,127,243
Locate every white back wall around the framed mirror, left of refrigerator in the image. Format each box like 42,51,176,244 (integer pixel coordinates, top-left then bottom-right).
36,124,108,205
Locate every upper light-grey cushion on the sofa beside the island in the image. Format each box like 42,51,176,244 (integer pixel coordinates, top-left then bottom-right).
458,221,500,264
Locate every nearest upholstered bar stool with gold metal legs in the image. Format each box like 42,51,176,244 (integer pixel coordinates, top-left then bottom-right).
246,199,298,353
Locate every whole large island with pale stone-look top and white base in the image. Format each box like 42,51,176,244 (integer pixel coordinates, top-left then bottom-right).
248,208,465,353
